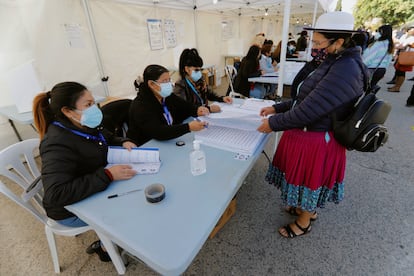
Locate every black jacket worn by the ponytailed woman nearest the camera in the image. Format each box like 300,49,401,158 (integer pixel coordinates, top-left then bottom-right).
40,122,125,220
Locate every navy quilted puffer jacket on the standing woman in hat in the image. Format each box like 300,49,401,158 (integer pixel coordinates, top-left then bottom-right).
269,47,368,131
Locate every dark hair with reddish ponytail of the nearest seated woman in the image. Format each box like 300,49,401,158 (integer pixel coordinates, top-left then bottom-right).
33,82,87,139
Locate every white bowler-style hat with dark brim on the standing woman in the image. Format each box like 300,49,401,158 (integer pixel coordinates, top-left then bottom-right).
304,11,358,33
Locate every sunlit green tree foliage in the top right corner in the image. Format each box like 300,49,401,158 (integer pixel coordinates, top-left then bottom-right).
354,0,414,30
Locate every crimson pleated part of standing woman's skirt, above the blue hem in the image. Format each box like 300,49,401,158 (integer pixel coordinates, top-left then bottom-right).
273,129,346,191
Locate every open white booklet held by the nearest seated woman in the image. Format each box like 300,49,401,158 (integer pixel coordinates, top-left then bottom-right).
107,147,161,174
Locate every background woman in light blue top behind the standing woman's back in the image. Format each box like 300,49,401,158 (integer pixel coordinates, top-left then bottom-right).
362,25,394,92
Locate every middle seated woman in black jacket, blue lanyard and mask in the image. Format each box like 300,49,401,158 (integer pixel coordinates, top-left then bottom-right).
127,64,209,145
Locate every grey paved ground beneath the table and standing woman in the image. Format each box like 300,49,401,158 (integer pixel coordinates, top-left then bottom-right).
0,70,414,275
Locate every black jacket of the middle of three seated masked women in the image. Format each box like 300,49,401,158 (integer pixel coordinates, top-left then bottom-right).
127,87,197,145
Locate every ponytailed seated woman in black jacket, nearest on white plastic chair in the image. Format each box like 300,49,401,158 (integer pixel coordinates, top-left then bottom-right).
33,82,136,262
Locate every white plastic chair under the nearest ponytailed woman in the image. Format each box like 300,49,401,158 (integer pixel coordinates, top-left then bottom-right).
0,139,92,273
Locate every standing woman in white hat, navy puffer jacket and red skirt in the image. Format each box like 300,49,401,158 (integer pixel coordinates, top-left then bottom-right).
258,12,368,238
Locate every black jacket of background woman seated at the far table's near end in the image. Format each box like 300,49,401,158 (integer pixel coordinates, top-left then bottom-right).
234,58,261,97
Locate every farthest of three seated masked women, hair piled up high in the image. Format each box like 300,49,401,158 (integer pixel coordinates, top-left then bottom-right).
174,49,232,112
